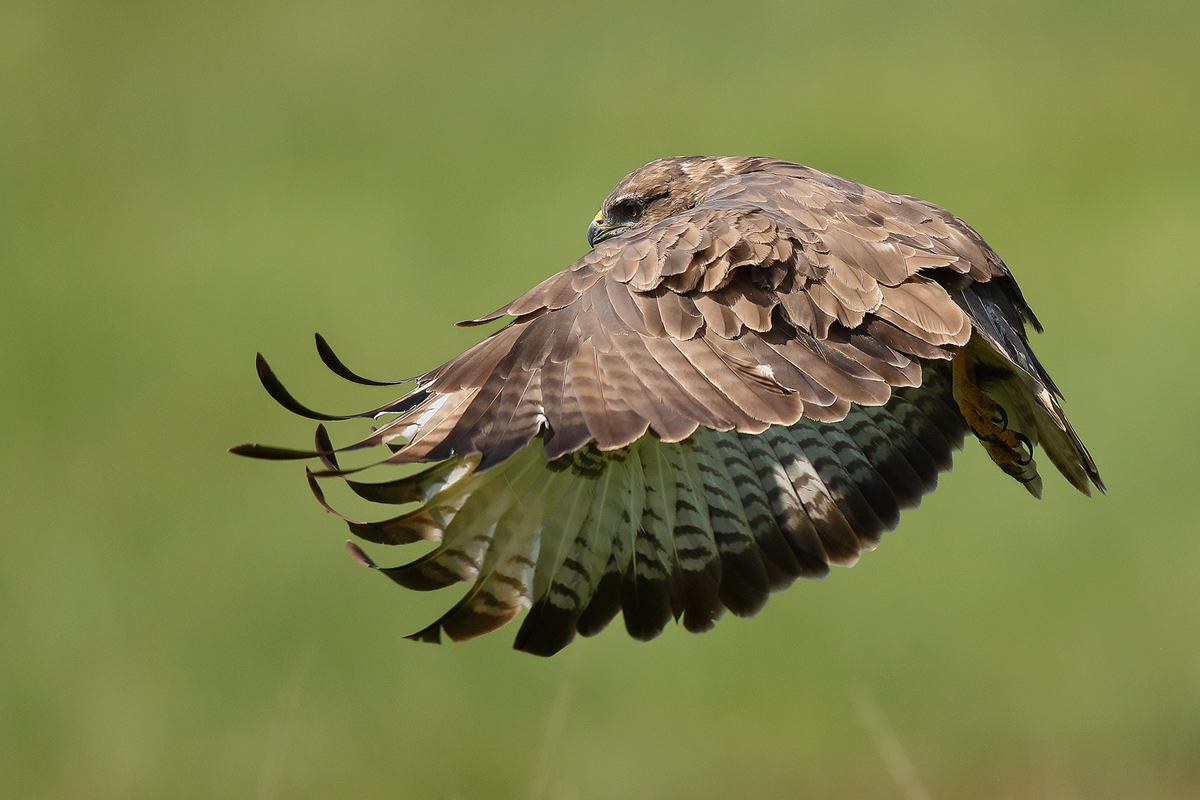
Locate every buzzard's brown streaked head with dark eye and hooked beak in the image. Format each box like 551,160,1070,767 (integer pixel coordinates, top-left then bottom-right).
588,156,746,247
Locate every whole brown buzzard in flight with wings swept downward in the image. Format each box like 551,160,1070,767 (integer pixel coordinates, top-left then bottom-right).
233,157,1104,655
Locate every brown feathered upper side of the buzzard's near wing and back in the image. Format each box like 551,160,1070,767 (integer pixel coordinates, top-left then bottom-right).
357,167,1004,467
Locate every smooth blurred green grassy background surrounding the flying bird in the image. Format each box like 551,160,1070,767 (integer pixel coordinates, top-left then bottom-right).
0,0,1200,800
